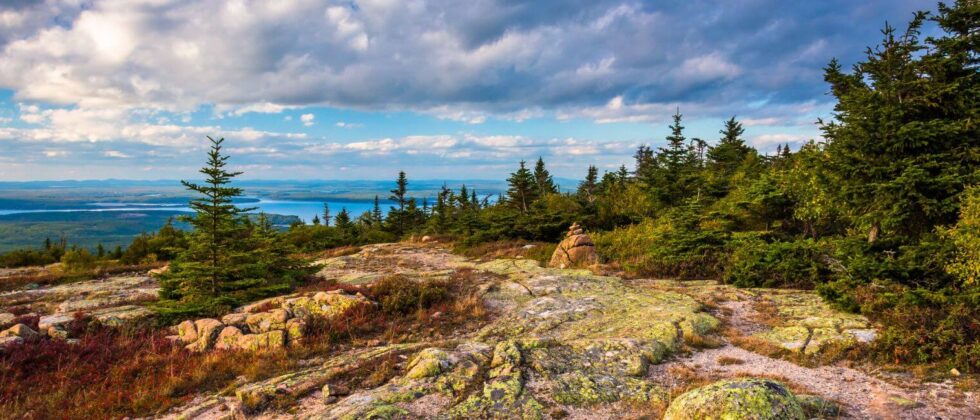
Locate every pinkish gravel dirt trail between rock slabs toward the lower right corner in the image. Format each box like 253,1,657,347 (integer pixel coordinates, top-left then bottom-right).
651,288,980,420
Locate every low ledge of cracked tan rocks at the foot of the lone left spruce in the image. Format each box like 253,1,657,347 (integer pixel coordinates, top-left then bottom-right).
170,290,373,352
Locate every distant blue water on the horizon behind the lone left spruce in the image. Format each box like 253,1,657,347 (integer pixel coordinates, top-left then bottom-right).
0,198,390,223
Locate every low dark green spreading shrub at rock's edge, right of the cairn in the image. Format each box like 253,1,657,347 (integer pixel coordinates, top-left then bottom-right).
723,234,830,288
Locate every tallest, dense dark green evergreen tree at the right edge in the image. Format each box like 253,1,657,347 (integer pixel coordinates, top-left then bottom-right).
822,9,980,242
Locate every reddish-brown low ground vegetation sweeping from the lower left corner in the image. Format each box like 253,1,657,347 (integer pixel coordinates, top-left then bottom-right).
0,271,487,419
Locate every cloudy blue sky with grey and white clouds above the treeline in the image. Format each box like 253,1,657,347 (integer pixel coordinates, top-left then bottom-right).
0,0,935,181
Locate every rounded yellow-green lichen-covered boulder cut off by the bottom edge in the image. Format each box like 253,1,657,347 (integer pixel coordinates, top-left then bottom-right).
664,378,806,420
